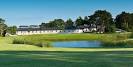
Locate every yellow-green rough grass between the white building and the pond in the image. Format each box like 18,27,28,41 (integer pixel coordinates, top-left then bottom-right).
13,34,128,47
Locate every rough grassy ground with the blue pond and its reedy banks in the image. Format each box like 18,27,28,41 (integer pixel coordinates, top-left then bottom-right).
13,34,133,48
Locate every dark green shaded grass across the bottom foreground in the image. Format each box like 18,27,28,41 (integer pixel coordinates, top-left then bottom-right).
0,51,133,67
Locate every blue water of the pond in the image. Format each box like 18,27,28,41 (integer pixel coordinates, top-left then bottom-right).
52,41,102,48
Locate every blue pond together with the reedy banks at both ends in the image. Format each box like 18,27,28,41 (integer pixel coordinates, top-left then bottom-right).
13,41,133,48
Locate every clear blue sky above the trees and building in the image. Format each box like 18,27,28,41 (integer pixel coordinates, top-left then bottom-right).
0,0,133,26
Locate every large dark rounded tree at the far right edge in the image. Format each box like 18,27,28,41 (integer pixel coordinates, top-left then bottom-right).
115,12,132,31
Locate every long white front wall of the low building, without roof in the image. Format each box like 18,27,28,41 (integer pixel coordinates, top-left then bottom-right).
16,29,83,35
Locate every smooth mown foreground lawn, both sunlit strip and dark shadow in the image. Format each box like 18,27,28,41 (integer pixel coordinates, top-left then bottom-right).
0,34,133,67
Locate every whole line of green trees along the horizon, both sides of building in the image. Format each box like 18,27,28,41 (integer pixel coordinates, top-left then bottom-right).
0,10,133,36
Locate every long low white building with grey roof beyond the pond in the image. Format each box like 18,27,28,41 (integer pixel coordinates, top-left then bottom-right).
16,25,96,35
